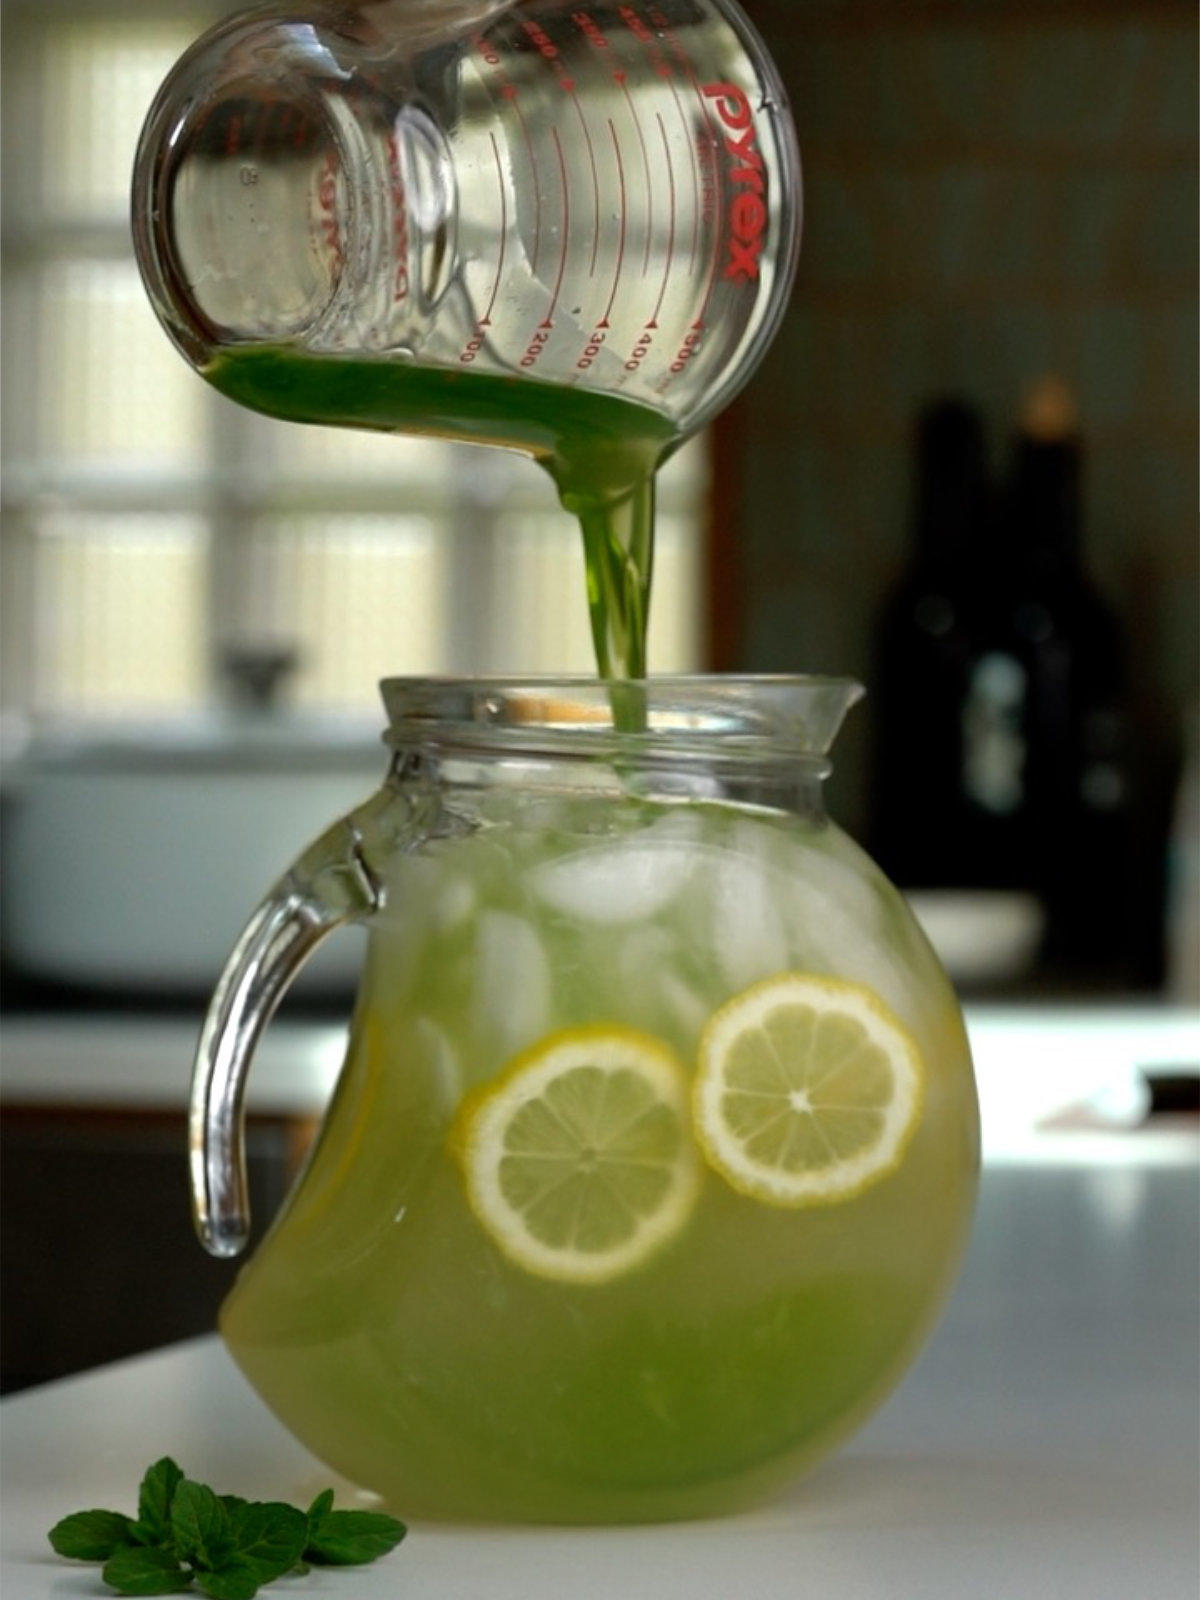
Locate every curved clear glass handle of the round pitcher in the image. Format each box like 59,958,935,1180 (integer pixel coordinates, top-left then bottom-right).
189,802,384,1256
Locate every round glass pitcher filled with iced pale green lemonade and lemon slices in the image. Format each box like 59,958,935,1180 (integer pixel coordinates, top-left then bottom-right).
197,678,978,1522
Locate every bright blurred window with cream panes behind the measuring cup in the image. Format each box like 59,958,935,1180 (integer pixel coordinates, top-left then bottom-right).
0,0,706,720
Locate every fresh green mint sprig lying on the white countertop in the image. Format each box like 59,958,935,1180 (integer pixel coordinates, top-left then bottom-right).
50,1456,408,1600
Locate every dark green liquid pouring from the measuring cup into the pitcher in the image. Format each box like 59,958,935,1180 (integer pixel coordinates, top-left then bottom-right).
205,346,682,694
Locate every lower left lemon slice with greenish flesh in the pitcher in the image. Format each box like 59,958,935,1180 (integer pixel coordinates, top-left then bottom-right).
453,1026,702,1283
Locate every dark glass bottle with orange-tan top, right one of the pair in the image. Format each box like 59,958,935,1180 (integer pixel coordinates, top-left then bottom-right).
963,379,1133,978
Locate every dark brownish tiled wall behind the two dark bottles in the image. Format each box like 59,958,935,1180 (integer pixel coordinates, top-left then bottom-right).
720,0,1198,822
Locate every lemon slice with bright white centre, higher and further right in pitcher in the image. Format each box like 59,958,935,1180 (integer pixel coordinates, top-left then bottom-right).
693,973,923,1206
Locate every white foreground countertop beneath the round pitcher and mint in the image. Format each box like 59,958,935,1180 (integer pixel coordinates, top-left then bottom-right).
0,1160,1200,1600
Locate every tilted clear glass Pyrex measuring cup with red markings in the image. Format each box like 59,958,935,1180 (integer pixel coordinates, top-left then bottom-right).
134,0,800,432
